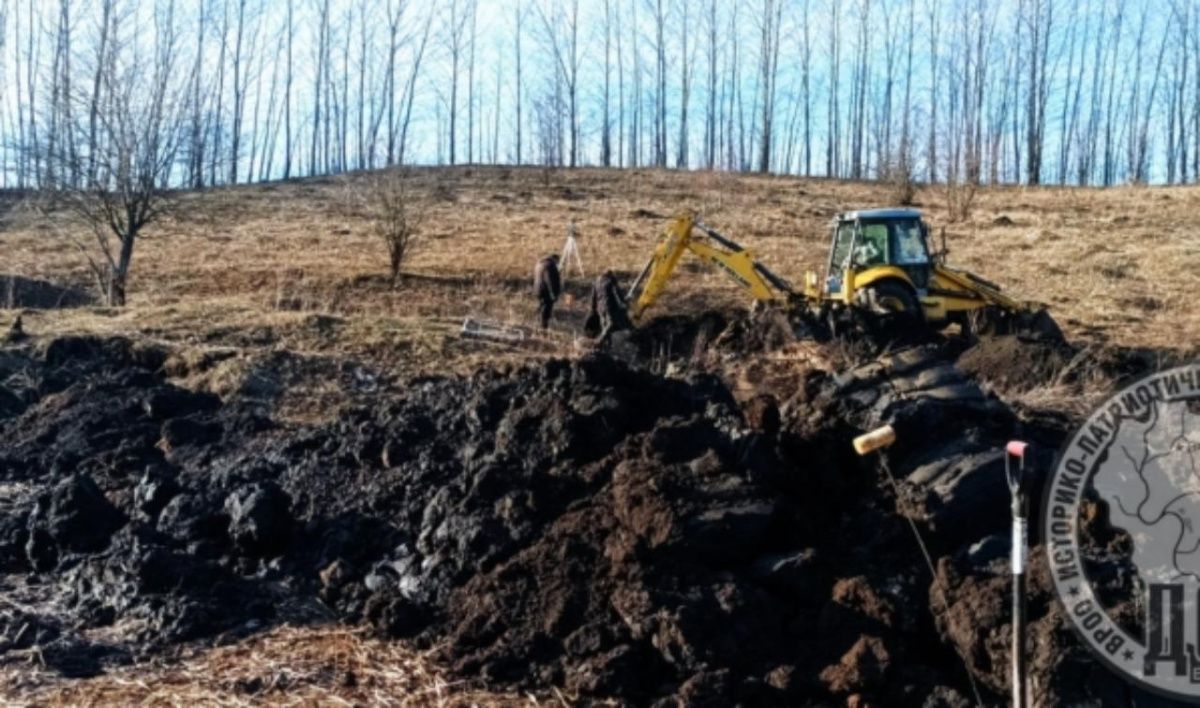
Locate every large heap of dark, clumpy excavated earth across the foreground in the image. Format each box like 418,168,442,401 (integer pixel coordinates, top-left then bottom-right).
0,317,1166,706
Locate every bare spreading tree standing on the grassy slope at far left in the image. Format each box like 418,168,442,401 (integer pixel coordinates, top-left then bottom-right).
35,2,182,307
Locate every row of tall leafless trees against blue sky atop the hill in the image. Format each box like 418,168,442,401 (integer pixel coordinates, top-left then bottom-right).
0,0,1200,192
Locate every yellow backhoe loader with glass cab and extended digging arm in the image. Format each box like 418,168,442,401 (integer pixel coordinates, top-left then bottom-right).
629,209,1062,340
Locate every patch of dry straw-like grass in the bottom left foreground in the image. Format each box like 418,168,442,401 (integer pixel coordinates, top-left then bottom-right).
0,626,544,708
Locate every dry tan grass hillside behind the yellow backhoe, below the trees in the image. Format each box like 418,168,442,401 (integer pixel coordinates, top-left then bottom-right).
0,167,1200,372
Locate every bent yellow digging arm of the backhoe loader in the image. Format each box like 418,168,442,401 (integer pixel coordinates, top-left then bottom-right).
628,214,794,319
